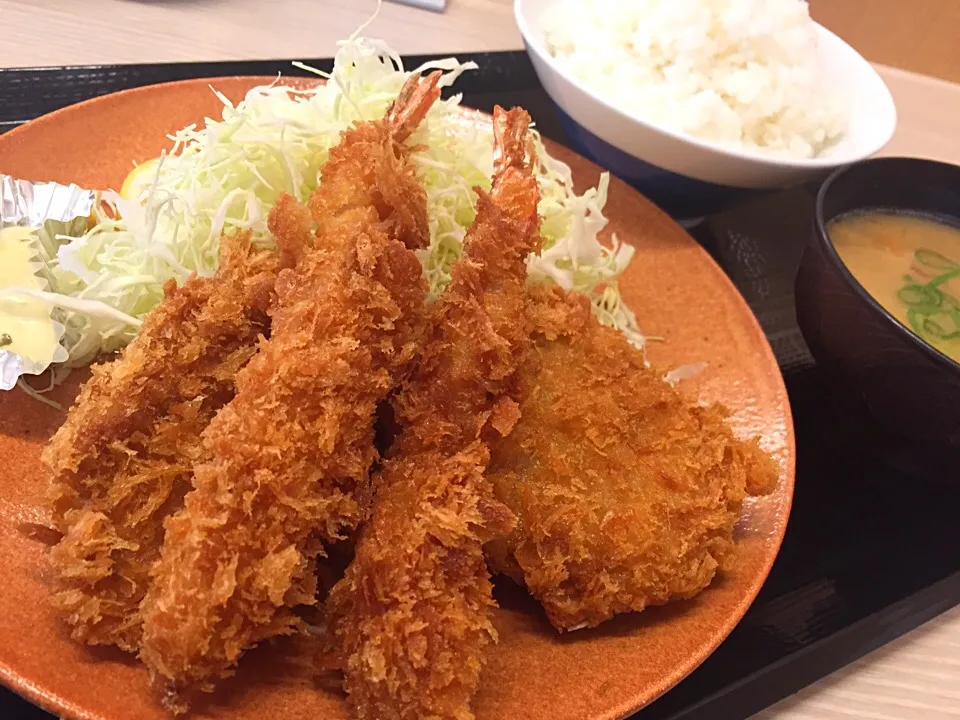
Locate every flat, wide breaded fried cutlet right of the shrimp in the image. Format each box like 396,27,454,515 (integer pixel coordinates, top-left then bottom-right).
488,288,778,630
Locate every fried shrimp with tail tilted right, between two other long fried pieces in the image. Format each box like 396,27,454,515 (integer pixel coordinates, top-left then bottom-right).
141,72,440,711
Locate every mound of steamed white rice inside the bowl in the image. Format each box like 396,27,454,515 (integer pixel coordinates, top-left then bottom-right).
544,0,846,158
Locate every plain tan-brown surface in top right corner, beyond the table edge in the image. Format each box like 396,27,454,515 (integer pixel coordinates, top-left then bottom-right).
809,0,960,82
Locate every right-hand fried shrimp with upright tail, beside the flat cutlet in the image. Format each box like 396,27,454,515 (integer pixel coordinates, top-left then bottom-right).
326,108,539,720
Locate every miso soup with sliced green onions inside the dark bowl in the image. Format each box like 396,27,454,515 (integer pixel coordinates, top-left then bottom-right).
827,213,960,362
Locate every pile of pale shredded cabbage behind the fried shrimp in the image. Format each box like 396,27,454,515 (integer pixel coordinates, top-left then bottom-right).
45,32,644,360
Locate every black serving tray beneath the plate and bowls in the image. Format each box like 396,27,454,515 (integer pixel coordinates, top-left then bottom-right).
0,52,960,720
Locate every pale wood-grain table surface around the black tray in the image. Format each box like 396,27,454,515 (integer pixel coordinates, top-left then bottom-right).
0,0,960,720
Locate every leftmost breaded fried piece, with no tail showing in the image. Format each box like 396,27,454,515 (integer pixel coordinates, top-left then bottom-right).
43,238,277,651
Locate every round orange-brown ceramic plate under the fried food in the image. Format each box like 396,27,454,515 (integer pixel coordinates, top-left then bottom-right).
0,78,794,720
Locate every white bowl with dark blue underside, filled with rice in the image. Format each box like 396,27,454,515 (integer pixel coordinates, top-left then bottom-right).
514,0,897,219
